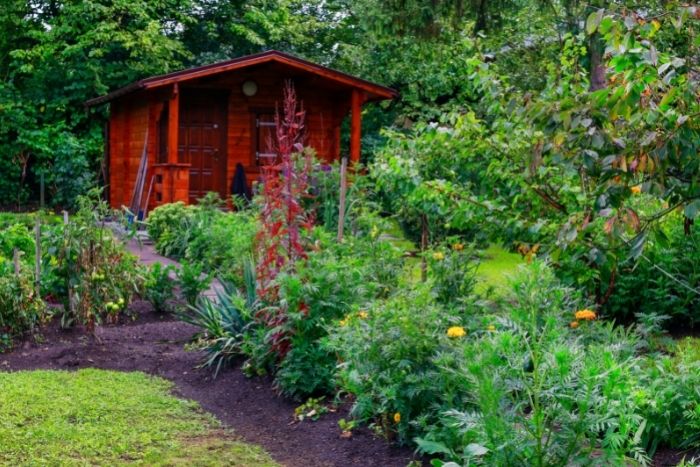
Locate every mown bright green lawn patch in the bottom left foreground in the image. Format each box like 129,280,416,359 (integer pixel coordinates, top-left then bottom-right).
0,369,277,466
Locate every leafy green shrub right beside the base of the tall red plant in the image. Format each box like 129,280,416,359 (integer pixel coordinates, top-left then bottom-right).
247,229,403,400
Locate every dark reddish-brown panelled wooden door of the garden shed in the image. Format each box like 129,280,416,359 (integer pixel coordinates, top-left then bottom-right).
178,89,228,203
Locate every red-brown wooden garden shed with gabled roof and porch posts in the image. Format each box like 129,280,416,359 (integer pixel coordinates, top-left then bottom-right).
86,50,396,209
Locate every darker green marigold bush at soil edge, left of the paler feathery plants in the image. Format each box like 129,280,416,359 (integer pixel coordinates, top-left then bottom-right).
330,287,466,442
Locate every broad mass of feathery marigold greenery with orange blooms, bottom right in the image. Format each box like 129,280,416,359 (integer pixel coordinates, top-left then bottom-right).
330,262,700,465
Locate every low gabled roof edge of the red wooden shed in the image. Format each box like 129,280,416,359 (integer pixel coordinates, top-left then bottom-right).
85,50,398,107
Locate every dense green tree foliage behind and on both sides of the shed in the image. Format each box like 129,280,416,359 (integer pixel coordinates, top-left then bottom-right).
0,0,700,318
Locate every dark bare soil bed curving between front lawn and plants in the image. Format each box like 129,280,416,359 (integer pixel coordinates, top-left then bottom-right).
0,302,422,467
